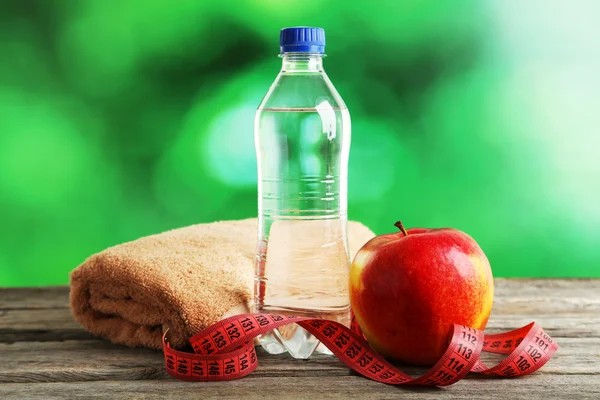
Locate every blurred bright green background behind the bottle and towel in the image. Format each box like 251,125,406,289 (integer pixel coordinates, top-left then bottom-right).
0,0,600,286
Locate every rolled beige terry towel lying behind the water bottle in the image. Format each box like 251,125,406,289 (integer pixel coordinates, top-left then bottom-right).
70,219,374,349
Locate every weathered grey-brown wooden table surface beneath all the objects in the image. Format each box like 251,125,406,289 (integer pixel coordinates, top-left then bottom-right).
0,279,600,400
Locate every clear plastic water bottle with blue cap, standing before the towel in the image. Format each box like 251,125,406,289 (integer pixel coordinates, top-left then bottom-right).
254,27,350,358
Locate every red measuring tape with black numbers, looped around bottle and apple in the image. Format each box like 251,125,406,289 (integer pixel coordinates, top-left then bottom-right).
163,314,558,386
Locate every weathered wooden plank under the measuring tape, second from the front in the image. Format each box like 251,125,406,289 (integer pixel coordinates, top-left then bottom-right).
0,338,600,383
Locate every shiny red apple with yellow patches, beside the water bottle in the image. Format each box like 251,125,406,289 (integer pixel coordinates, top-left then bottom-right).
350,222,494,365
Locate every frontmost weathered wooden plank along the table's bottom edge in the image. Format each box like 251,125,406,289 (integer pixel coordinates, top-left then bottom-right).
0,374,600,400
